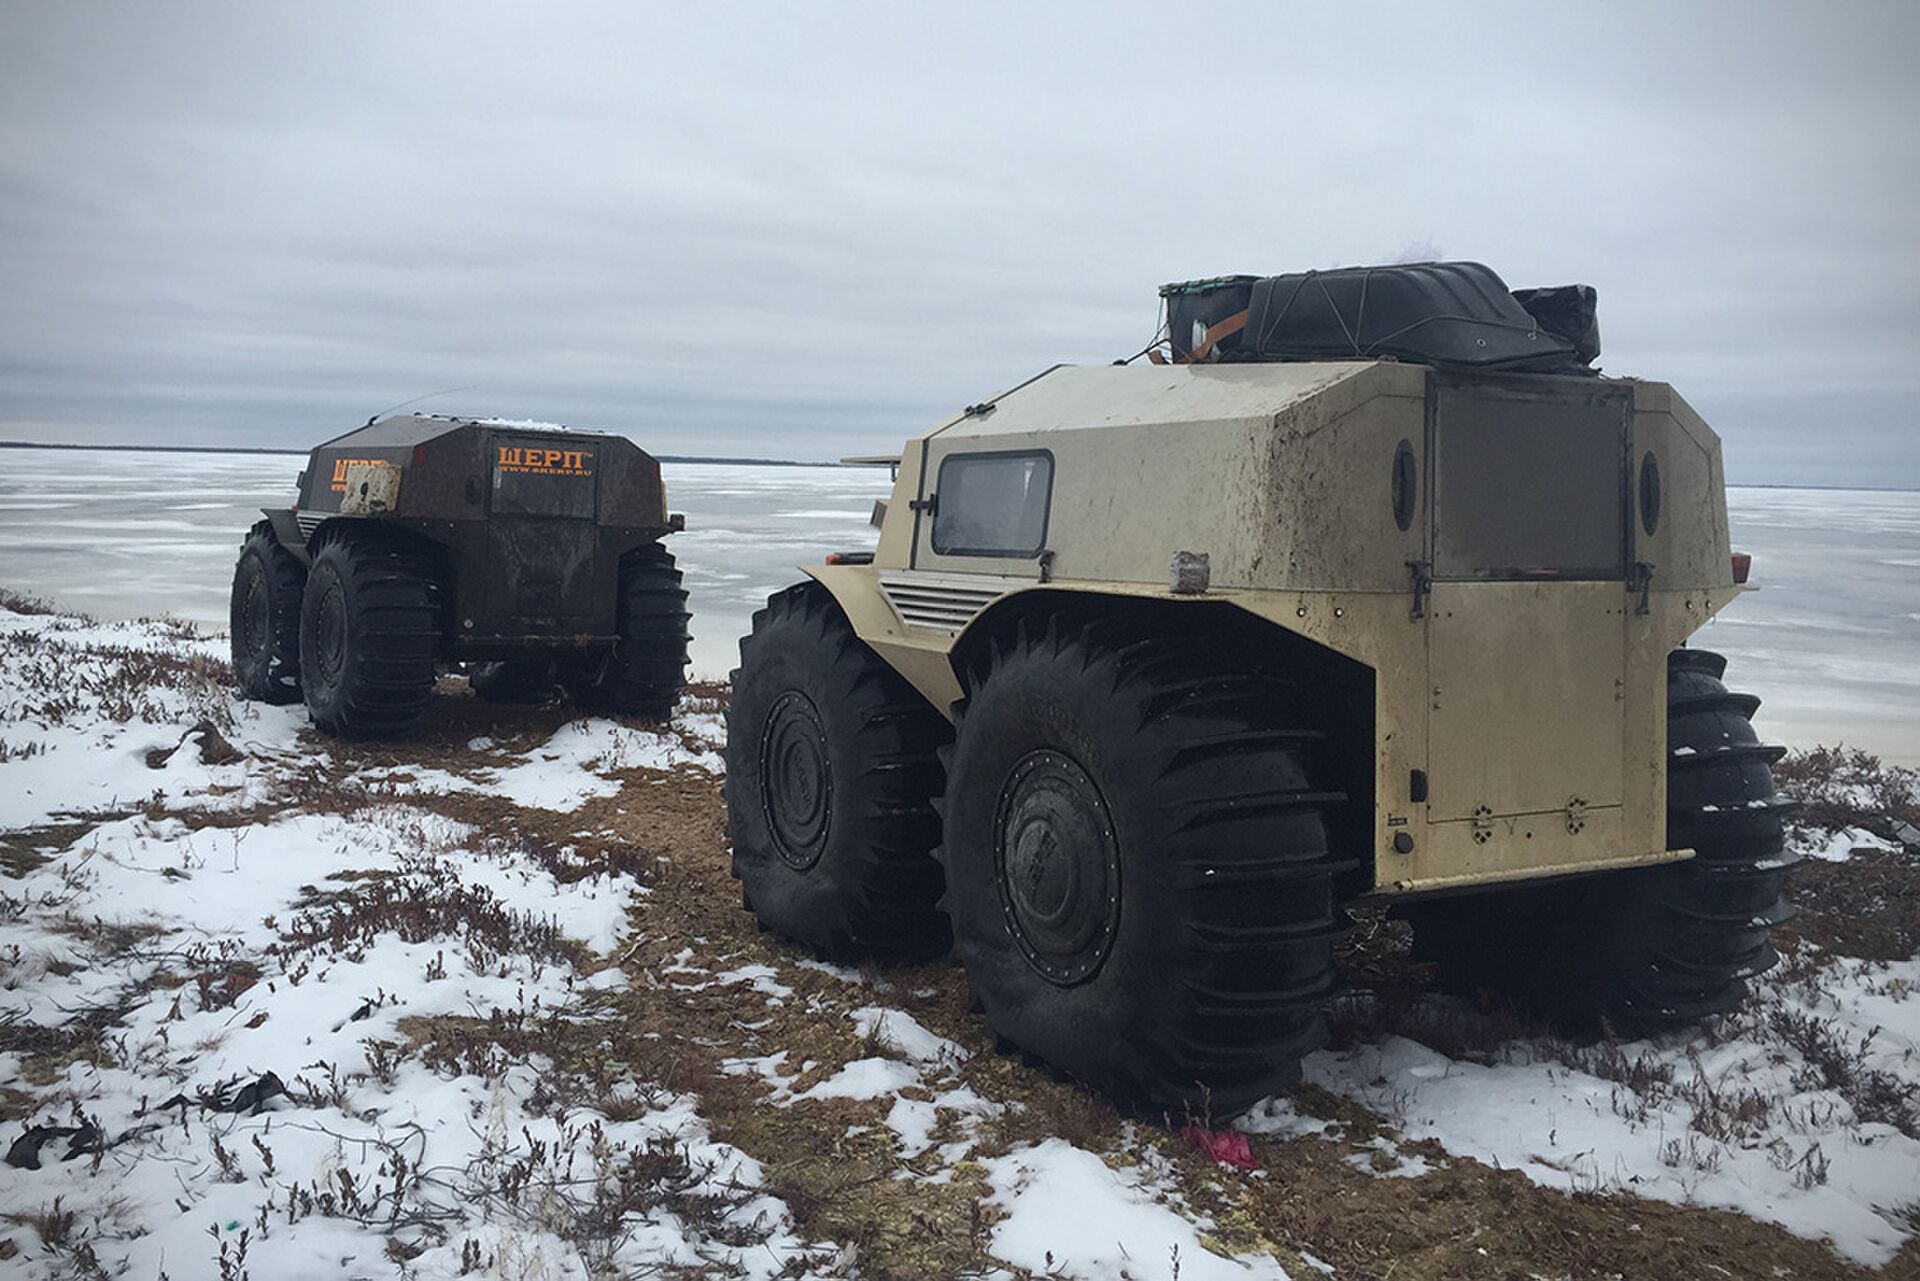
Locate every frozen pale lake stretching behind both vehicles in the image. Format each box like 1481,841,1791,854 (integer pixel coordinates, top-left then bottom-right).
0,449,1920,764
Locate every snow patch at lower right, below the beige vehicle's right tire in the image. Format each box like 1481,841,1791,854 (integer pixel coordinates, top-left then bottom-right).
1240,956,1920,1268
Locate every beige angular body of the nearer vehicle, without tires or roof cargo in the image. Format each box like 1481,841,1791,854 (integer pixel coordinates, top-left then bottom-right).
814,363,1740,893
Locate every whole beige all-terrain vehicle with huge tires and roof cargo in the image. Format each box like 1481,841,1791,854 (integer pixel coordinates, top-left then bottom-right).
728,263,1786,1114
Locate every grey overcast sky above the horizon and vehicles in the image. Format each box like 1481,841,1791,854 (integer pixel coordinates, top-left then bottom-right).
0,0,1920,486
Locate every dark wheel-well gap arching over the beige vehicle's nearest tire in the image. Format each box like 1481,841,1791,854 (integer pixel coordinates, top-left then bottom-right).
948,592,1375,899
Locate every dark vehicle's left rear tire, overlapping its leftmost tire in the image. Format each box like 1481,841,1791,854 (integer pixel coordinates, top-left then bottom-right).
300,532,440,737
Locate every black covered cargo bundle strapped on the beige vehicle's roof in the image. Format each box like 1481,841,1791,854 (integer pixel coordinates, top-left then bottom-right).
1160,263,1599,375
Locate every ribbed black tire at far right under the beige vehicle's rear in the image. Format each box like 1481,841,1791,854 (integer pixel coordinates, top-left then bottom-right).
1407,649,1795,1033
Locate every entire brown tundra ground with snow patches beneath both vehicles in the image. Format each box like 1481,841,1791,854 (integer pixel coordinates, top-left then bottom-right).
0,597,1920,1281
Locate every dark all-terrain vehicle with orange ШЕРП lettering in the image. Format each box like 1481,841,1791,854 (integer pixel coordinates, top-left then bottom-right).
232,415,687,736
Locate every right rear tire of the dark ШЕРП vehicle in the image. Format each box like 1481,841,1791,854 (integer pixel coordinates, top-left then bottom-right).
566,544,691,720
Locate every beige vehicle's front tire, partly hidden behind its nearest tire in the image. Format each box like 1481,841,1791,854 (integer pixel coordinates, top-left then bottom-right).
726,584,950,960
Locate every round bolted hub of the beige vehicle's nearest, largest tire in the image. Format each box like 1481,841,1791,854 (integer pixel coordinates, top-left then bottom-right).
993,751,1119,987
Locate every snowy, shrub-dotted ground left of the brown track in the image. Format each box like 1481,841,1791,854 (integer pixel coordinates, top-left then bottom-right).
0,611,839,1279
